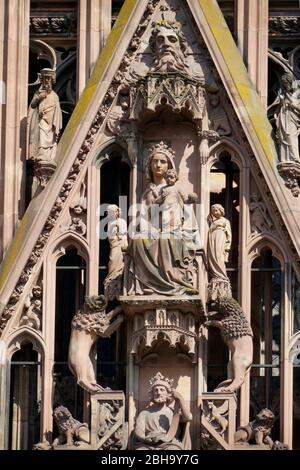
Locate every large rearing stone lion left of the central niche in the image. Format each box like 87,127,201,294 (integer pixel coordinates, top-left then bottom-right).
68,295,124,393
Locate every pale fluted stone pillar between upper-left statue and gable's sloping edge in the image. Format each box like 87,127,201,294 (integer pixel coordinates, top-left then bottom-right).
77,0,112,98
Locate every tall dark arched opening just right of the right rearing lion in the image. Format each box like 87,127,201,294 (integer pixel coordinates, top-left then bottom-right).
250,249,282,439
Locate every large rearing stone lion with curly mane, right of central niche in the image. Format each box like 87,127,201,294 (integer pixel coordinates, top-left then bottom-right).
204,297,253,392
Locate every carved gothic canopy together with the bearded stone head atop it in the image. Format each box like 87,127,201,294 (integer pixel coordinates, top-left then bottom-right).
128,20,217,124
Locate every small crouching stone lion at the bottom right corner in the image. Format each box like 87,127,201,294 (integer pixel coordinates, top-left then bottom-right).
234,408,275,449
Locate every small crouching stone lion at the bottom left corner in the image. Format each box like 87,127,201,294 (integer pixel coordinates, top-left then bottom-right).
52,406,90,449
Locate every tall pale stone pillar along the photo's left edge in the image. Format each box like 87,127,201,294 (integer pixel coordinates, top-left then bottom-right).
0,0,30,260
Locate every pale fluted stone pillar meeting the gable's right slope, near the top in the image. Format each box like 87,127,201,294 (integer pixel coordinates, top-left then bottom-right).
236,0,269,108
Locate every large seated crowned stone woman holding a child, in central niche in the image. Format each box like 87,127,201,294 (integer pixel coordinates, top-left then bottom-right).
125,142,201,296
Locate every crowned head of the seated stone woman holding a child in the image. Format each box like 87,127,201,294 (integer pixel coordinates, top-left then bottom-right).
146,142,176,183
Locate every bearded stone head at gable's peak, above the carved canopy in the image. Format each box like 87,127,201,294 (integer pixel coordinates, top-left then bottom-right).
150,20,187,72
